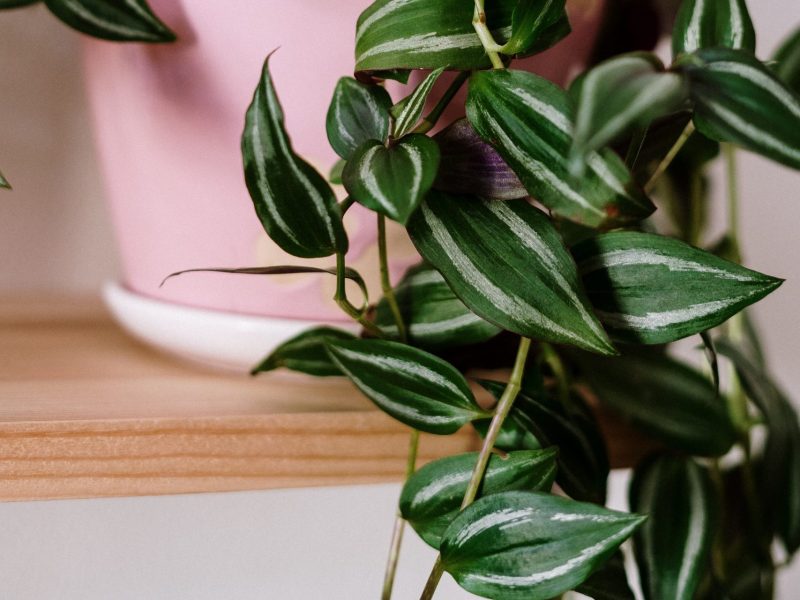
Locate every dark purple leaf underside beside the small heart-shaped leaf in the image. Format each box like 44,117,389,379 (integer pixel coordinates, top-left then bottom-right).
433,119,528,200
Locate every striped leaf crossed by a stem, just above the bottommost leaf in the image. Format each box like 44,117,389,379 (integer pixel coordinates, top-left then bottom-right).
400,448,557,549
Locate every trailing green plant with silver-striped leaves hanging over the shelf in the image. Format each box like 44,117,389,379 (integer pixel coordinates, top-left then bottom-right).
172,0,800,600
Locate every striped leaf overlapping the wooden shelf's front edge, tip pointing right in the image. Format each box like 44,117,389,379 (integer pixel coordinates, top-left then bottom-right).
328,340,488,435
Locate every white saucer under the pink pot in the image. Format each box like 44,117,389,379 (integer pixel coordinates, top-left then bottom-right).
103,282,356,373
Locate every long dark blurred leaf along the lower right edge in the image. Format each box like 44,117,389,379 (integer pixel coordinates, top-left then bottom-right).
717,339,800,555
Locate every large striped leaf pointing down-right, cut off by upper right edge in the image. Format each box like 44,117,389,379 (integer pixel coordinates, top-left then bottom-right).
684,48,800,169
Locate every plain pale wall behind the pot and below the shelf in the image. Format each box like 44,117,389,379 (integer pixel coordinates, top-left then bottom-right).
0,0,800,600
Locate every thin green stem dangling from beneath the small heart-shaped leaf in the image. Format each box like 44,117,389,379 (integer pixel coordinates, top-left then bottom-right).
378,214,419,600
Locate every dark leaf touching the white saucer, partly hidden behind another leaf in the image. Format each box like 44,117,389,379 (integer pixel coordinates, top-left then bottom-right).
250,327,356,377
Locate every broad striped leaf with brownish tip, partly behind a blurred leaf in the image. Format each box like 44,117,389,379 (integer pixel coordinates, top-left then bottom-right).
467,70,654,227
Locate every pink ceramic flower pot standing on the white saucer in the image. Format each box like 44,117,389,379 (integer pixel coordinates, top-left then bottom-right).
85,0,596,367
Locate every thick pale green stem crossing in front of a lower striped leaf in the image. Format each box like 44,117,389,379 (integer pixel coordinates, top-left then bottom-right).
420,338,531,600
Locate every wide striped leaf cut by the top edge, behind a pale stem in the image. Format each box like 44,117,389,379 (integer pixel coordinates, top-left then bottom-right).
356,0,518,72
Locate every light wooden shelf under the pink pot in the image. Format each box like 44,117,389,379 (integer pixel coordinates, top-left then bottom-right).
0,297,641,500
